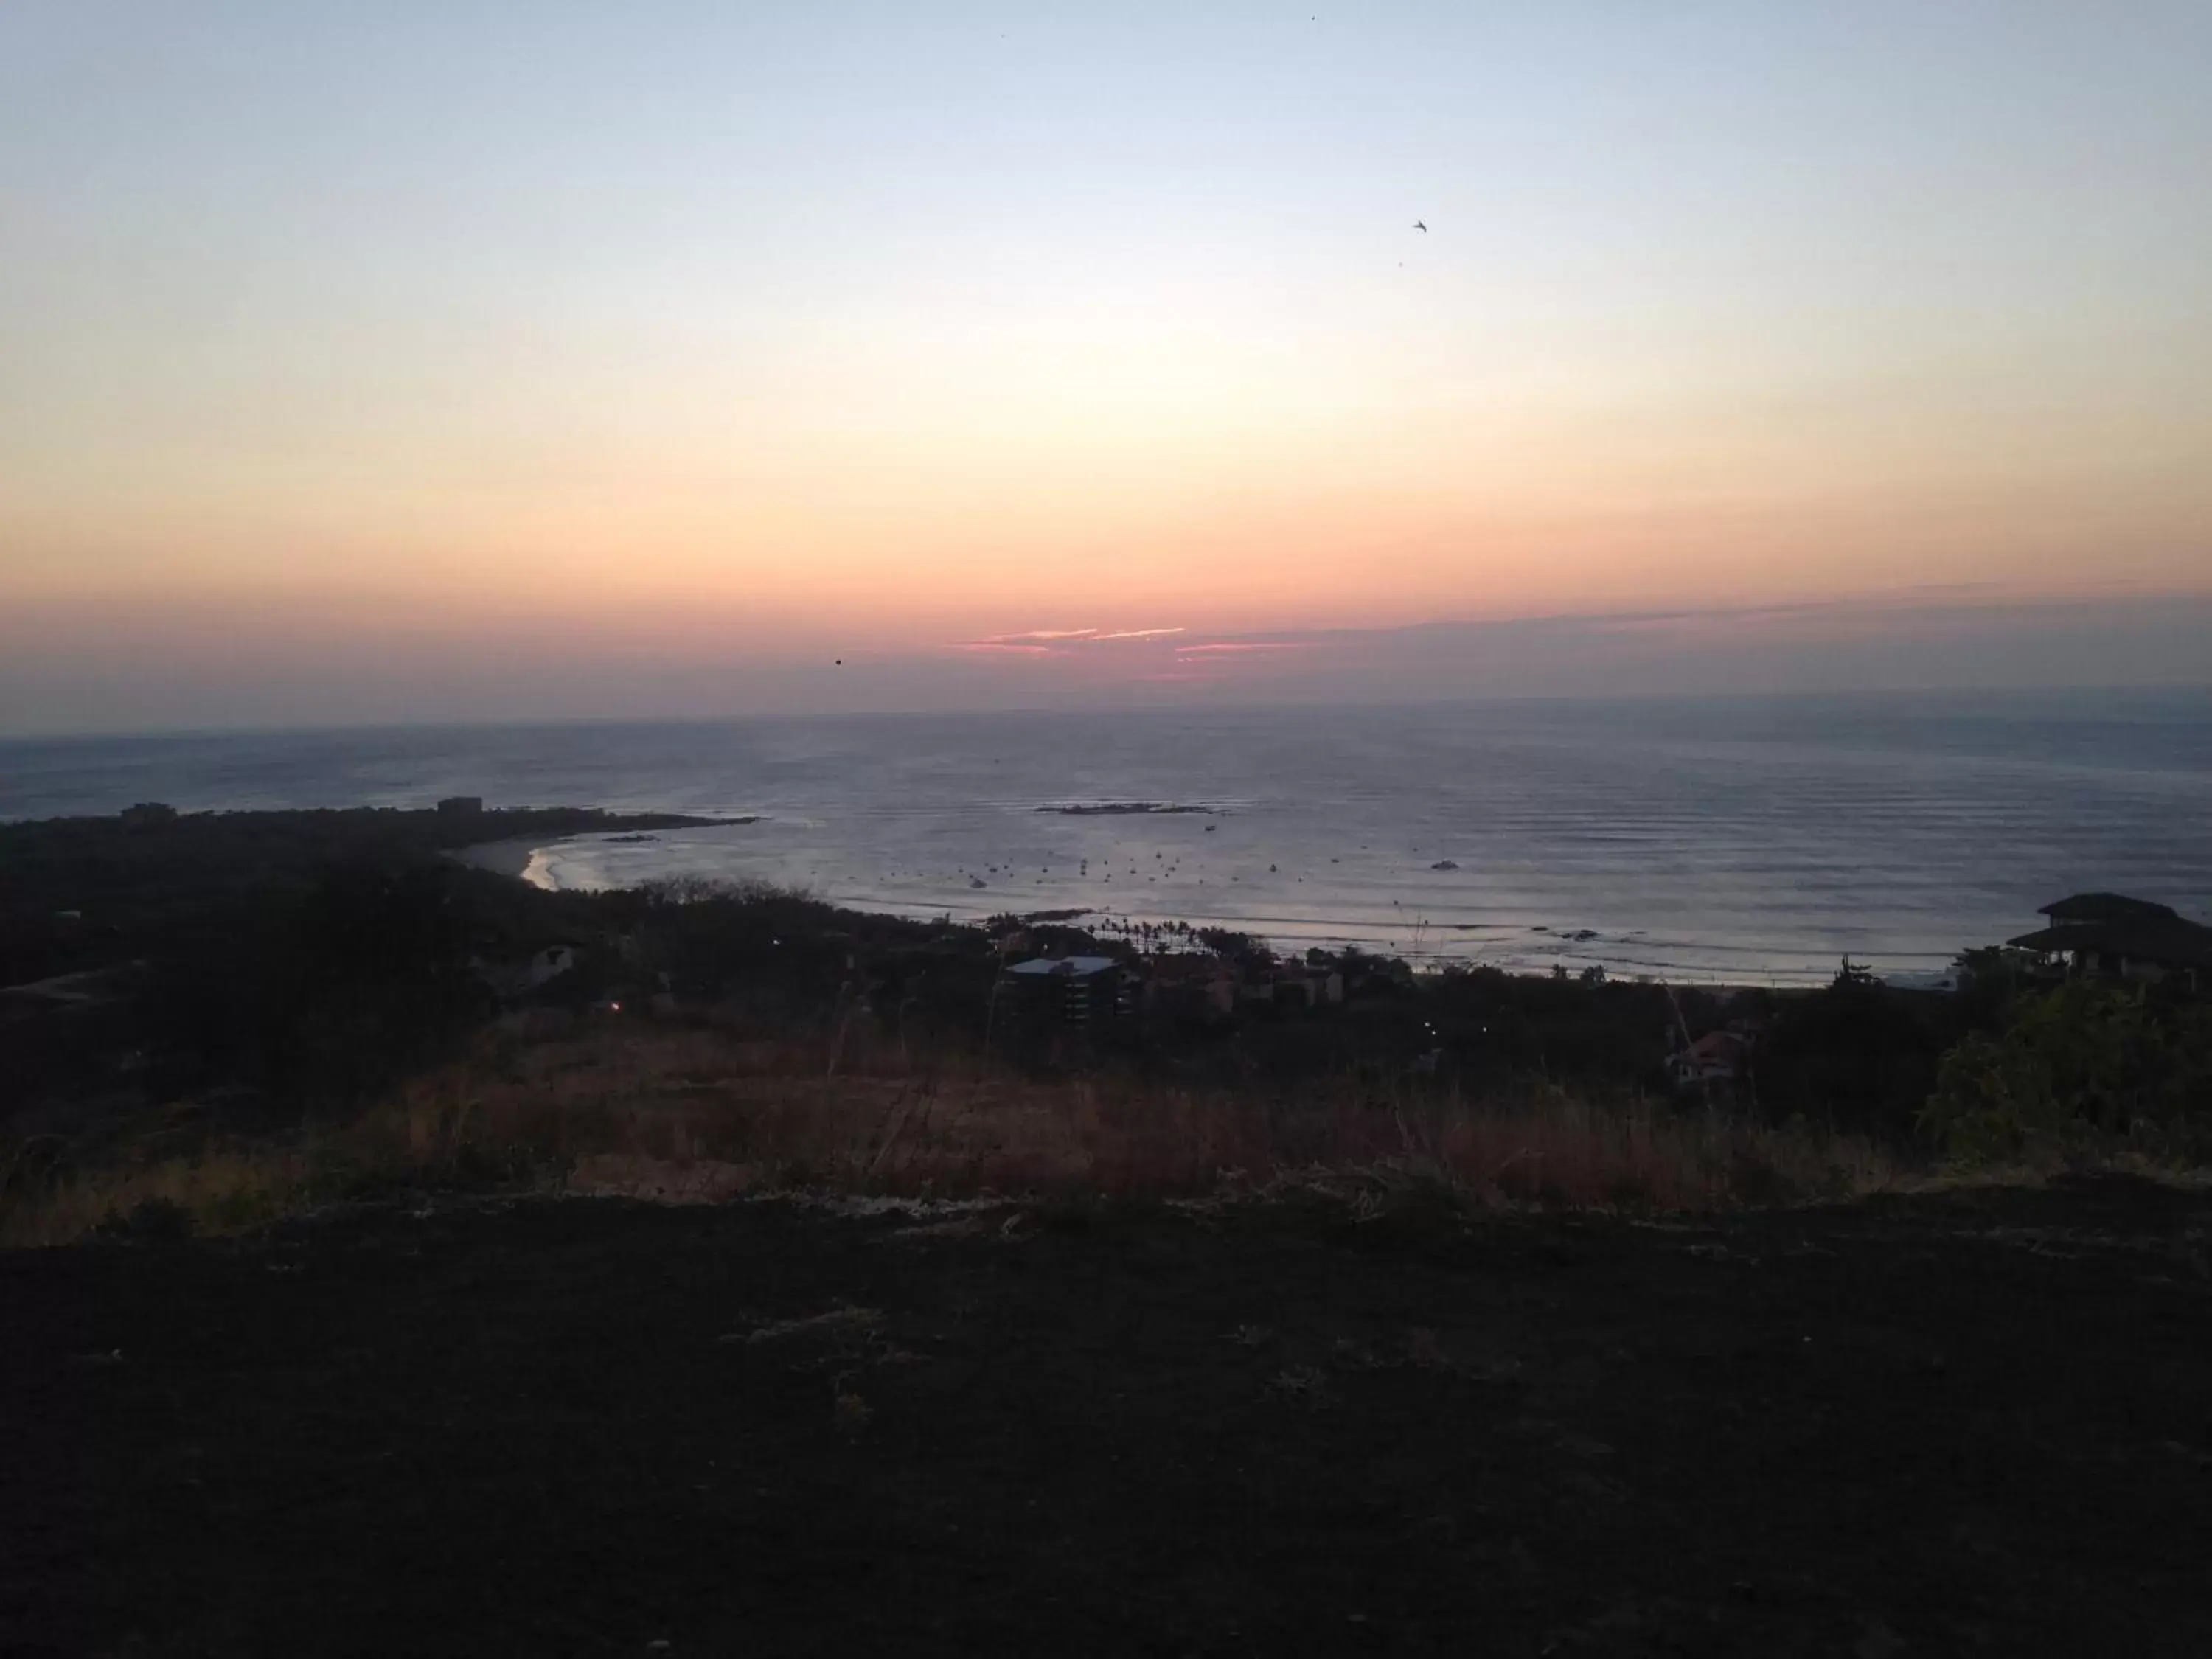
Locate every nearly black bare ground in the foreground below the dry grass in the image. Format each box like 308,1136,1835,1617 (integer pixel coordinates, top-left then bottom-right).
0,1183,2212,1659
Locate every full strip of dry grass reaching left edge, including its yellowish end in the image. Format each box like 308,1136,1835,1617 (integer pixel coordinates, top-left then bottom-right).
0,1026,1900,1243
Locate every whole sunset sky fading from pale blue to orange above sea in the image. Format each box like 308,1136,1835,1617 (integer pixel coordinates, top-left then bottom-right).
0,0,2212,732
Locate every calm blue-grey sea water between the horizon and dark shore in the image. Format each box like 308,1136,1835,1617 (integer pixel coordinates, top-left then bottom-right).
0,692,2212,982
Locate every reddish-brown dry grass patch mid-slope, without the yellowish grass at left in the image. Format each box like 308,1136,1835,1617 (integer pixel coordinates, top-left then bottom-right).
363,1031,1898,1210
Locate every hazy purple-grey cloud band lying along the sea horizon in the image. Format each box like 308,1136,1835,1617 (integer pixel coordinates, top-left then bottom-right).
0,593,2212,734
